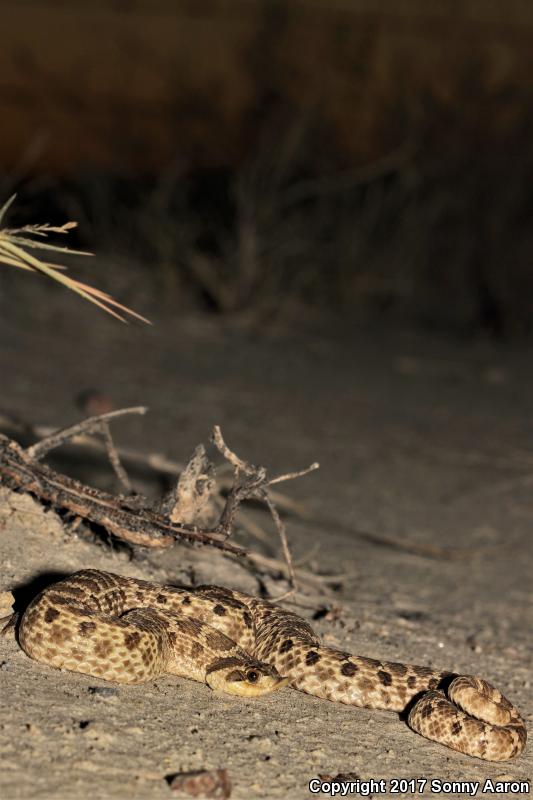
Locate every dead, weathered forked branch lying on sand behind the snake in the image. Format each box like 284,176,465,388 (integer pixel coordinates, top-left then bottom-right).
0,407,318,587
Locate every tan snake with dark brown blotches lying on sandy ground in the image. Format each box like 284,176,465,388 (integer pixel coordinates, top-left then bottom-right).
18,569,527,761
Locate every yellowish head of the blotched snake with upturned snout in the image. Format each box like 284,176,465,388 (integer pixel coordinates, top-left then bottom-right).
206,658,289,697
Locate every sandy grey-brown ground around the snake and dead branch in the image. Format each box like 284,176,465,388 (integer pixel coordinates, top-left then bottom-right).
0,272,533,800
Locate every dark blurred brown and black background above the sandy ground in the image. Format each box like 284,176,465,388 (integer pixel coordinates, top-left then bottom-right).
4,0,533,340
